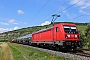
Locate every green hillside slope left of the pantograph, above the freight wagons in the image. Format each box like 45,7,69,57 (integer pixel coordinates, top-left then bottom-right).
0,25,52,41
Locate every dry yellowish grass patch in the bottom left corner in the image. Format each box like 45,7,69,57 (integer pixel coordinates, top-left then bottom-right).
0,43,13,60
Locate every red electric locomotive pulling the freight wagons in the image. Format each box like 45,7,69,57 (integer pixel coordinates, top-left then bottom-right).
31,23,81,50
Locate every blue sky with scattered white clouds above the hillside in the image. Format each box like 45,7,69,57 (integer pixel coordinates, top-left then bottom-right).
0,0,90,33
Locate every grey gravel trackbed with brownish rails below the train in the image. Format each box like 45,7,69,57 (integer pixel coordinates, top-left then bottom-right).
17,44,90,60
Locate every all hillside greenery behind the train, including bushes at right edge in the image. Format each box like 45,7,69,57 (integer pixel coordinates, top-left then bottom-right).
0,22,90,48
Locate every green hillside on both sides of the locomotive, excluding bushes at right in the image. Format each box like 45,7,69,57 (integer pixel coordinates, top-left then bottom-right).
0,22,87,41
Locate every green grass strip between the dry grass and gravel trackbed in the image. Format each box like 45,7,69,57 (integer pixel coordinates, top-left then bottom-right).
9,43,69,60
